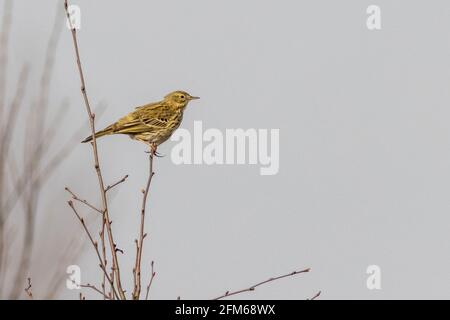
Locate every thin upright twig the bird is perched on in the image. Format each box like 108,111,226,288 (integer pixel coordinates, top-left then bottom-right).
132,149,156,300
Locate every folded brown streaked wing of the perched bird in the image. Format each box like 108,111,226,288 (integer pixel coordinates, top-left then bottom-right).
114,102,170,134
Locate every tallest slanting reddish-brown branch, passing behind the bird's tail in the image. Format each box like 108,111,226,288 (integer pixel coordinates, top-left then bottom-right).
64,0,126,300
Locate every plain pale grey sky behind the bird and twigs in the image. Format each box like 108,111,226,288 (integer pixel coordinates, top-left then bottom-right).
5,0,450,299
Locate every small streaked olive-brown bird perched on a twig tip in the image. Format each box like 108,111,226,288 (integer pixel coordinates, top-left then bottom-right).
82,90,200,154
